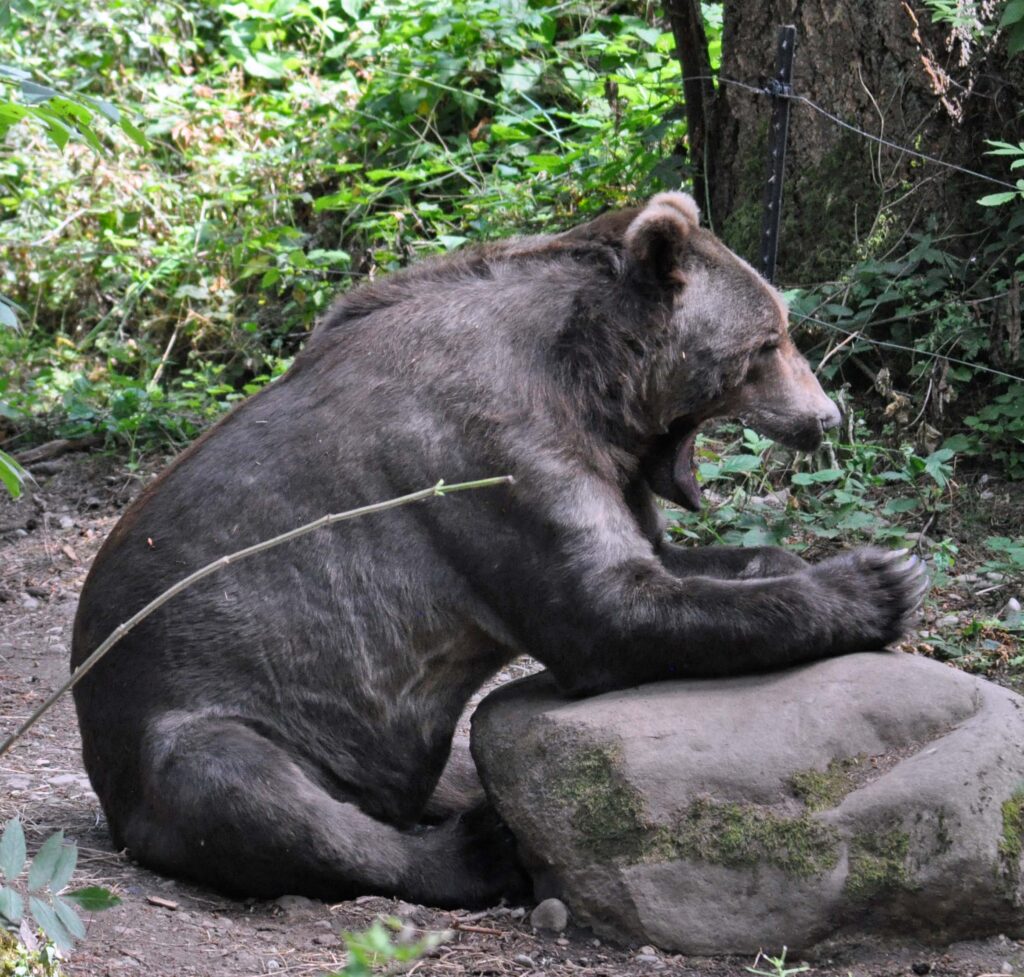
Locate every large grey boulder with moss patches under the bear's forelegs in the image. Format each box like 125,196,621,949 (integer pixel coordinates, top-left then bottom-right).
473,653,1024,953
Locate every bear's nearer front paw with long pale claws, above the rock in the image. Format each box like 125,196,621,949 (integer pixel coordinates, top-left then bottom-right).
811,547,929,651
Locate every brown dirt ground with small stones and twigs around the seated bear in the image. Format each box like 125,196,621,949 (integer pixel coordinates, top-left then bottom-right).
0,455,1024,977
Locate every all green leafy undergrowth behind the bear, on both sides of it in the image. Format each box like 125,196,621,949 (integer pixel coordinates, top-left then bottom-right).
0,0,1024,661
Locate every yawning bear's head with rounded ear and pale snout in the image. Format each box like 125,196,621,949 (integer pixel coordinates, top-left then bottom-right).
623,194,841,509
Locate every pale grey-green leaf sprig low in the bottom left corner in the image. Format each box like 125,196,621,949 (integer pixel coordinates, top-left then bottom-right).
0,818,120,950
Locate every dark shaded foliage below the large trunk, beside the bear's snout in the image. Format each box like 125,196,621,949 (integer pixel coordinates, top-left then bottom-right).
788,211,1024,478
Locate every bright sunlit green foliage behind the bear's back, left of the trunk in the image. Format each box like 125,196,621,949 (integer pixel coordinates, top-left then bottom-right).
0,0,704,448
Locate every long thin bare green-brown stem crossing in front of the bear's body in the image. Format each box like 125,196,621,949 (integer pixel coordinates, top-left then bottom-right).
0,475,513,757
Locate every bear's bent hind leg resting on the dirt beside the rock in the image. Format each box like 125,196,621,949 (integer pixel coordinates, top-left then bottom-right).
116,716,521,906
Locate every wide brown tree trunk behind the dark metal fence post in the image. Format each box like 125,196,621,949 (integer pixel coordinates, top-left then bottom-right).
709,0,1024,285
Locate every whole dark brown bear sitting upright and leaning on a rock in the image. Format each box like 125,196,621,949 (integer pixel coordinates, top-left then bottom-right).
72,193,926,906
